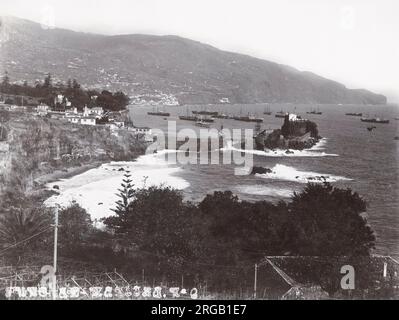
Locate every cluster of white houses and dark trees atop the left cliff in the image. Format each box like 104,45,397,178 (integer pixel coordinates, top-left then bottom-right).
0,73,152,141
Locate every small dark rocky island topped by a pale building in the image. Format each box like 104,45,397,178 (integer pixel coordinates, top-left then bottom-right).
255,113,321,151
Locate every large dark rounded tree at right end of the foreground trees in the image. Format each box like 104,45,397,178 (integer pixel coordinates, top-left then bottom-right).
289,183,375,256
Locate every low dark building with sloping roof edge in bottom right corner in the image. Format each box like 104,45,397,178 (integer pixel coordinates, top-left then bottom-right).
256,255,399,300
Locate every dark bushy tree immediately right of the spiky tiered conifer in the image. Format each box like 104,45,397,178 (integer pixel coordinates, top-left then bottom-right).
104,186,196,273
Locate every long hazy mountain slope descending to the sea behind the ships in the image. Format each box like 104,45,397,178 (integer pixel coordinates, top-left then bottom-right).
0,17,386,104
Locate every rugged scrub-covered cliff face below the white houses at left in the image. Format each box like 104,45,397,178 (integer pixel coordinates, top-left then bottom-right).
0,115,146,192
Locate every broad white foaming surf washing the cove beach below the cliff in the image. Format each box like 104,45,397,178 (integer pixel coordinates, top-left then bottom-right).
45,154,190,220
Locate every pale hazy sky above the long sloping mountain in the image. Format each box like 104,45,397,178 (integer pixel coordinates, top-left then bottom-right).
0,0,399,102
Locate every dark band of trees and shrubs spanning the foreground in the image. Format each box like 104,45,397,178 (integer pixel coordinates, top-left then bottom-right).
0,173,388,294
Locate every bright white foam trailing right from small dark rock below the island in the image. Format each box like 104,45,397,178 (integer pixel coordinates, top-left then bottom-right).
255,164,352,183
